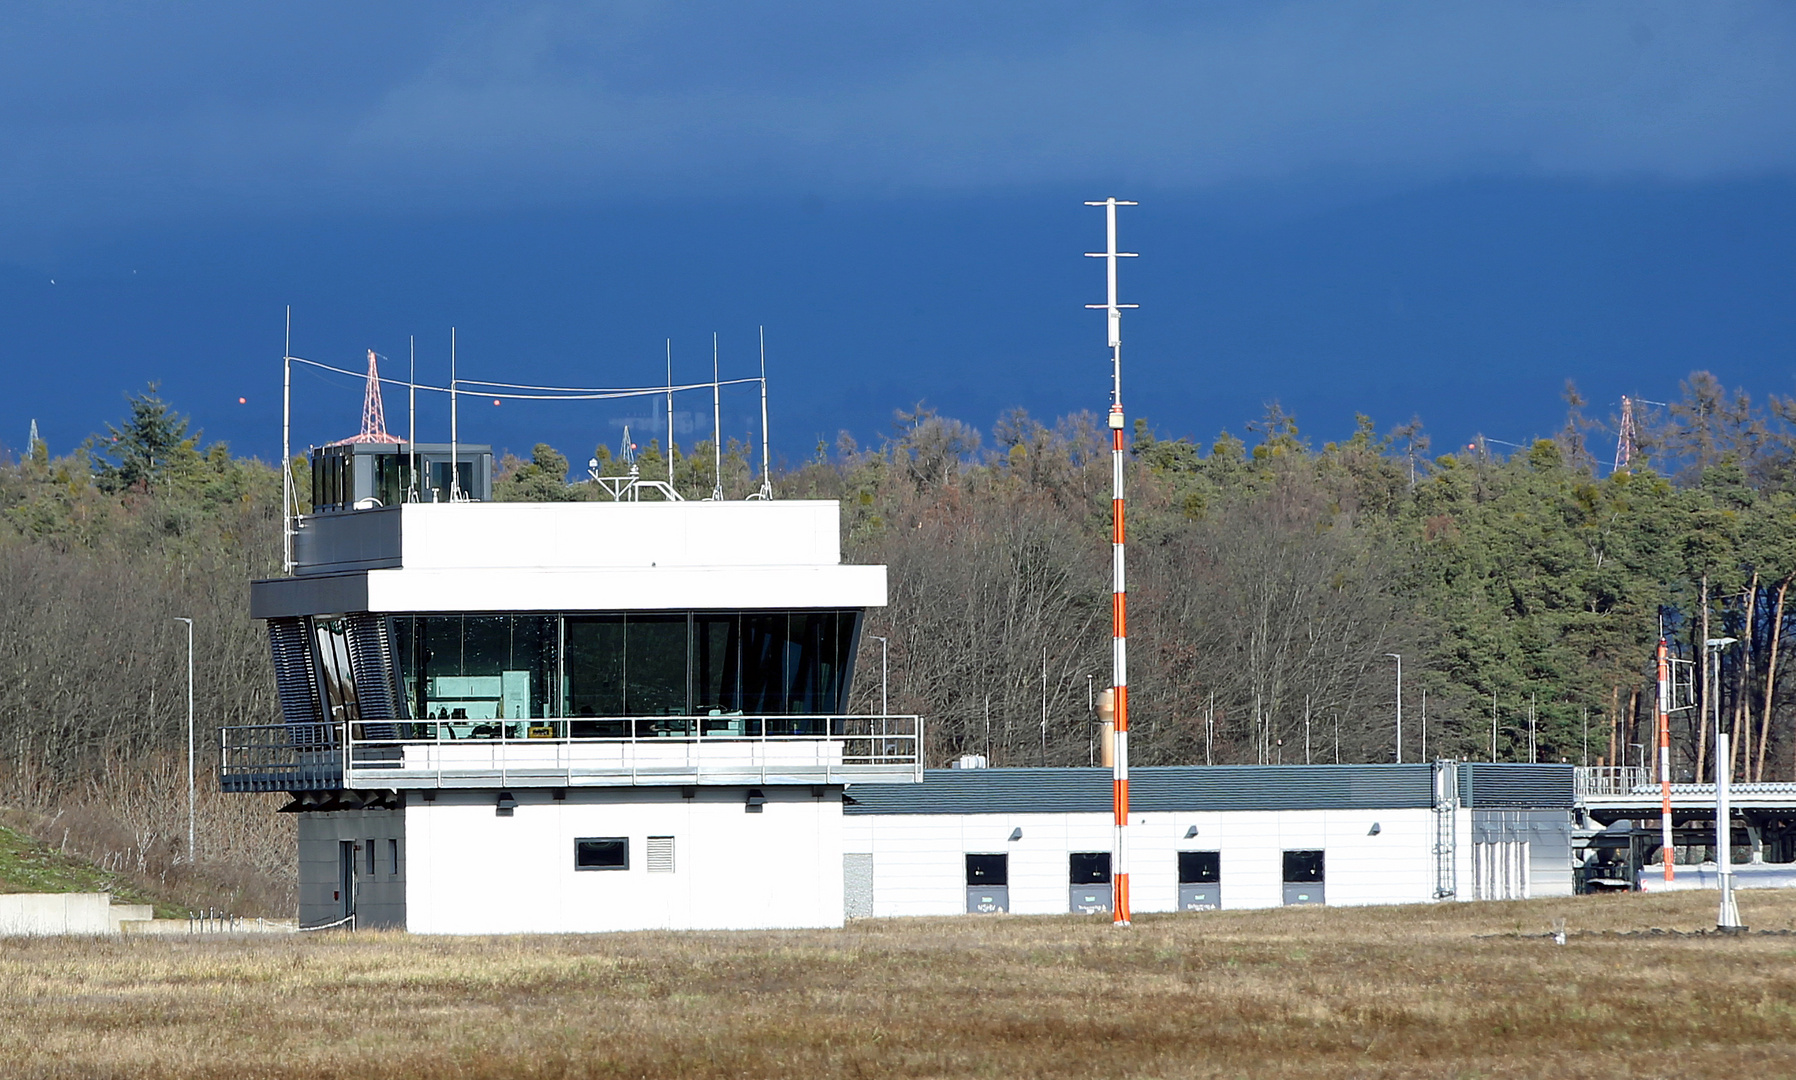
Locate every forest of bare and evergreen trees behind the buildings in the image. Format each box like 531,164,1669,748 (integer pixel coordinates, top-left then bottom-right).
0,372,1796,915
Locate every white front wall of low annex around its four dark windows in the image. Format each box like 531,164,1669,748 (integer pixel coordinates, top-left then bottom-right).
844,809,1433,916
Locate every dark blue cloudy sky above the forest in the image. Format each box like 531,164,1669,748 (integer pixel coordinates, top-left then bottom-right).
0,0,1796,458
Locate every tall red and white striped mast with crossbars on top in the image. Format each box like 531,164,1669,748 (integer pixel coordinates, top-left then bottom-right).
1085,198,1139,925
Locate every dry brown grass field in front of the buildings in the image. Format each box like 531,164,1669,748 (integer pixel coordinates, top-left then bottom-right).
0,891,1796,1080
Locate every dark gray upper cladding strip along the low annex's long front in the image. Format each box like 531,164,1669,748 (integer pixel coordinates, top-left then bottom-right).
842,764,1433,814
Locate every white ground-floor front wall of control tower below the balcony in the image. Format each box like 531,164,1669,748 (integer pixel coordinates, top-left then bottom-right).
404,787,842,934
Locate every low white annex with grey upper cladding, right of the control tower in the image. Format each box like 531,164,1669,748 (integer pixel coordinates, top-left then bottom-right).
844,762,1573,916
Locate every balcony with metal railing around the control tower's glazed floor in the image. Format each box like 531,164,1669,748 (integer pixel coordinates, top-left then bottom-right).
219,715,923,791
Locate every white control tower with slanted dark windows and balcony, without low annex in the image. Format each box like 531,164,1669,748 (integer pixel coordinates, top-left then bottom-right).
221,446,921,933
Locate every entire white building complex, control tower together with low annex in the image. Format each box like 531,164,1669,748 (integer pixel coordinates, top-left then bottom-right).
221,444,1572,933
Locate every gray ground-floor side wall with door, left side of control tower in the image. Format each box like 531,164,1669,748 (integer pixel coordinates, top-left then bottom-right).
300,809,406,929
